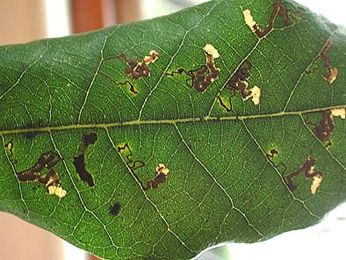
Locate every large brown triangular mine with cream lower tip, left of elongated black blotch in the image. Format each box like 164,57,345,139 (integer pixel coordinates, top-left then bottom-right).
16,151,66,198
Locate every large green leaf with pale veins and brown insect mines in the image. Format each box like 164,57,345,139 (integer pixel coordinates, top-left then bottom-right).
0,0,346,259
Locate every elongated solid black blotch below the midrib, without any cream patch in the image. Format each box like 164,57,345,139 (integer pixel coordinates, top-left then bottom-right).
73,133,98,187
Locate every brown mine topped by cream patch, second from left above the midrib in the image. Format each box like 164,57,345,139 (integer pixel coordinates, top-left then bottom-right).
166,44,220,93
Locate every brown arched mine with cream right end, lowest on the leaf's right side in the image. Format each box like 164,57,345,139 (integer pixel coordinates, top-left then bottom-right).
286,156,323,195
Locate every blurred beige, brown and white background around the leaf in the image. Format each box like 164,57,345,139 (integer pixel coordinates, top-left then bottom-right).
0,0,346,260
